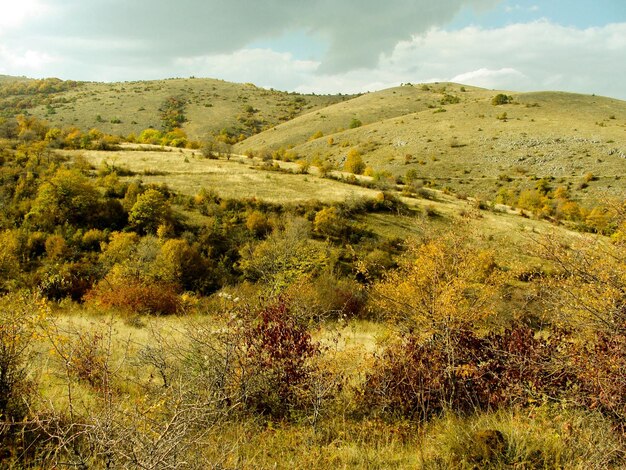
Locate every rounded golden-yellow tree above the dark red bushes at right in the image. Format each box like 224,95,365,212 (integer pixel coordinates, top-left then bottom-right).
372,233,501,335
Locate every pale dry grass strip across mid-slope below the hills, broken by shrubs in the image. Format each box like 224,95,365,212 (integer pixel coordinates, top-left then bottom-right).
75,143,584,265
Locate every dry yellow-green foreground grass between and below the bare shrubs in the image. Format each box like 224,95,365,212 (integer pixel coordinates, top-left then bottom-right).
20,304,625,470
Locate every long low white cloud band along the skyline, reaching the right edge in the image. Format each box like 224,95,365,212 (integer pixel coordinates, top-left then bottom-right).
129,20,626,99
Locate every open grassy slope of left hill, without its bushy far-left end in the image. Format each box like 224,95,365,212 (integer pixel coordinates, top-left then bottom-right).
20,78,347,139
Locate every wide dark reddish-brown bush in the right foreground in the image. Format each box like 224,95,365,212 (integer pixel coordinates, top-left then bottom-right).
362,325,575,420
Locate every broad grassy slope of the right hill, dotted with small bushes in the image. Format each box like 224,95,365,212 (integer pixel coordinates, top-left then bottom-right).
237,84,626,202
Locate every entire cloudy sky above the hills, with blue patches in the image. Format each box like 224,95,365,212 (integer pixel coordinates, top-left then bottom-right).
0,0,626,100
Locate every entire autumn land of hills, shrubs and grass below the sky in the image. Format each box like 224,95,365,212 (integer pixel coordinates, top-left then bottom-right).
0,73,626,469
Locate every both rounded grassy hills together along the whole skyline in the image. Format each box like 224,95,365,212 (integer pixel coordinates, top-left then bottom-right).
0,77,626,205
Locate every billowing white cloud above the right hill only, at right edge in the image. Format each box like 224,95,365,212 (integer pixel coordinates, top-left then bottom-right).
379,20,626,99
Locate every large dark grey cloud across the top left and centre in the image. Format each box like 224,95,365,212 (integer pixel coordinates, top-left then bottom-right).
3,0,499,73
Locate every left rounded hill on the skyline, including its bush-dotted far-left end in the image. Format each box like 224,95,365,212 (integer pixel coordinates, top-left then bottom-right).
0,77,350,140
